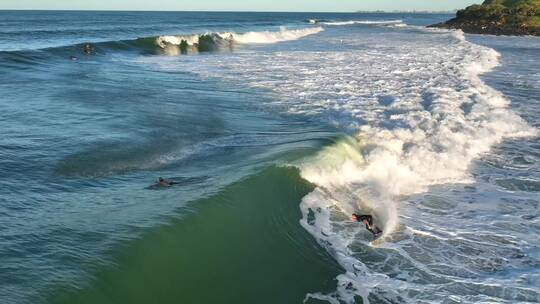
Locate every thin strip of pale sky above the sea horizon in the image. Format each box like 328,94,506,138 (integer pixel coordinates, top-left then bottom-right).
0,0,482,12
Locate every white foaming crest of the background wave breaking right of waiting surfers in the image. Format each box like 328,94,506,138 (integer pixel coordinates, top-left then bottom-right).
156,27,324,47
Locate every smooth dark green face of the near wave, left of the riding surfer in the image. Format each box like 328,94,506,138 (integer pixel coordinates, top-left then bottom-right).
50,167,342,304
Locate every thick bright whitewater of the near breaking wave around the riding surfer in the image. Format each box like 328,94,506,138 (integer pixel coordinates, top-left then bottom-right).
300,31,538,303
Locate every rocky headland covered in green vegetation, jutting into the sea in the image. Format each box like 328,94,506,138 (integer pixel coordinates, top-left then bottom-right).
435,0,540,35
